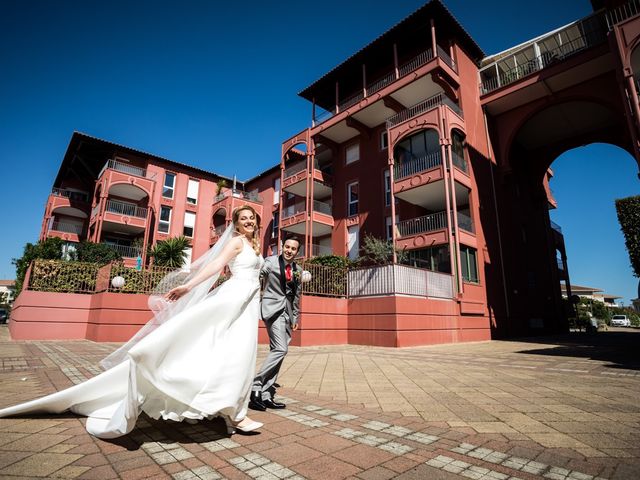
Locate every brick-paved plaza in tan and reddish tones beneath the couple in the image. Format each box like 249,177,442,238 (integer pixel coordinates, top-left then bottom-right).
0,326,640,480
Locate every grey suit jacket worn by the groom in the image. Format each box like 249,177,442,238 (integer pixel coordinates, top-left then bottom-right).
260,255,302,326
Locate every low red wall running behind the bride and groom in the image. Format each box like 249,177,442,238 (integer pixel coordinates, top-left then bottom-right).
9,291,491,347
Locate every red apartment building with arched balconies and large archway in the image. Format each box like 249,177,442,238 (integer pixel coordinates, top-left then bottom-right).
12,0,640,346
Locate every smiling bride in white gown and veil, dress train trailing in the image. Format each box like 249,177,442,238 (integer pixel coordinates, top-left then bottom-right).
0,206,264,438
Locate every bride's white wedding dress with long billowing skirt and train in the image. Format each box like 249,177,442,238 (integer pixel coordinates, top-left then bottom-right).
0,241,264,438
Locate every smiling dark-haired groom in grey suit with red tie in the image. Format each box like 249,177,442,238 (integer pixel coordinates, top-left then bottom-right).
249,236,302,411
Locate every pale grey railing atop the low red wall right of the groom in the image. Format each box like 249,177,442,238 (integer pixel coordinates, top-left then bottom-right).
347,264,453,298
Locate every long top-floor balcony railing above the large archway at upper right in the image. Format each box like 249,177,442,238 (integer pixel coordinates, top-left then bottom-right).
480,14,606,95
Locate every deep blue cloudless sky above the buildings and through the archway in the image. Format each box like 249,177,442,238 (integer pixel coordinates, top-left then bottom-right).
0,0,640,302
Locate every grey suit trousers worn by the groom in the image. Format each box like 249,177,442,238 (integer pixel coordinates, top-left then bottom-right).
251,308,291,400
